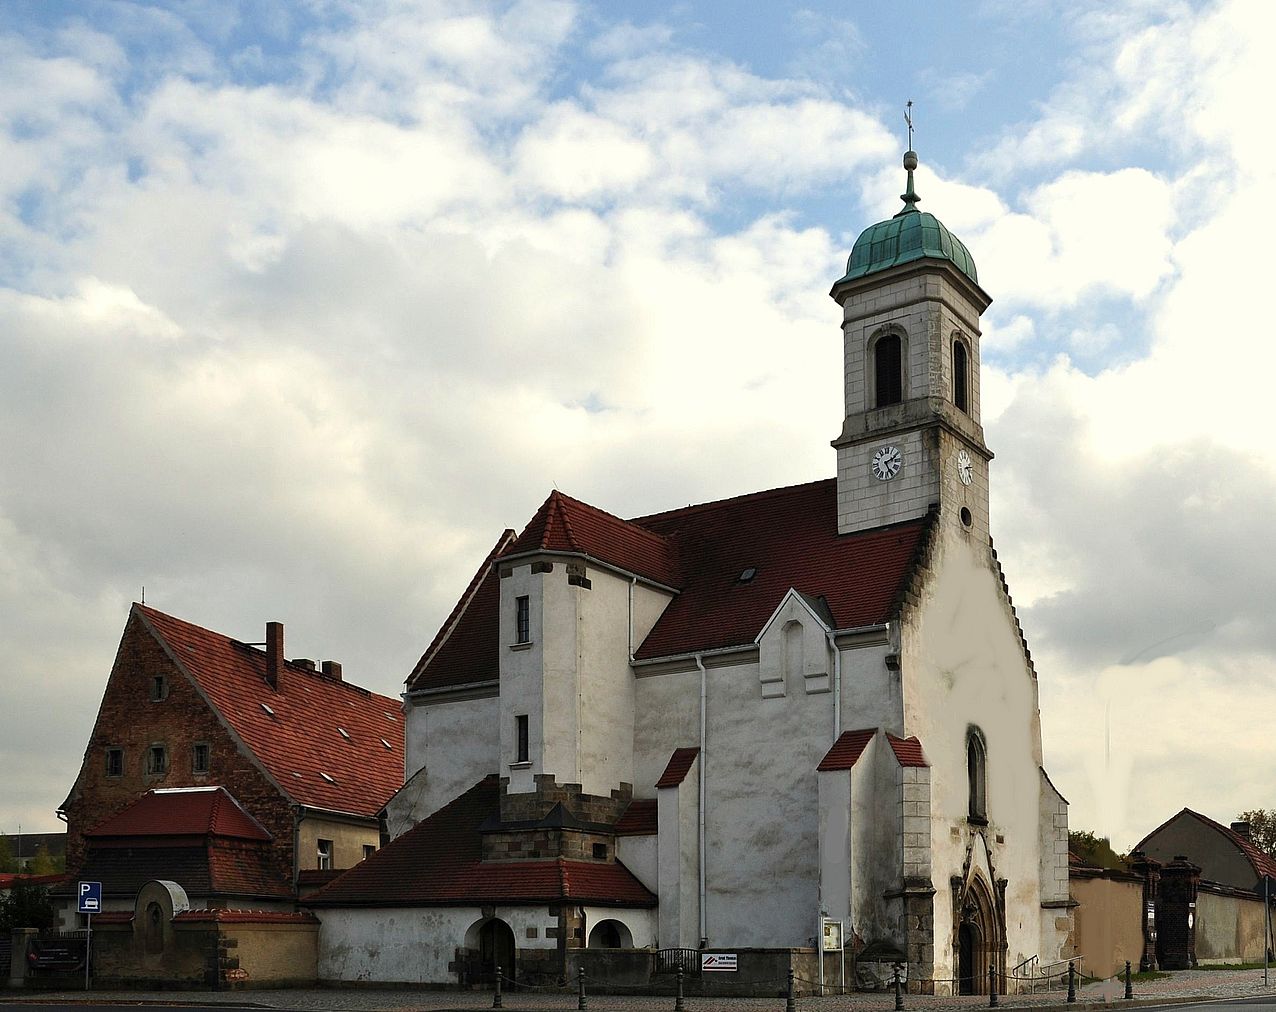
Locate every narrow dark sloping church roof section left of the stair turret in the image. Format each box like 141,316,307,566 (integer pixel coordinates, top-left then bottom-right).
407,531,514,692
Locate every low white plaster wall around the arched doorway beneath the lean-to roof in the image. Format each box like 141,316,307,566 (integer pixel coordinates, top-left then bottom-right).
314,906,558,984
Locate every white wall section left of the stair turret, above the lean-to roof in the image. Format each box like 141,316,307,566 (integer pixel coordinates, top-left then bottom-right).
398,692,500,838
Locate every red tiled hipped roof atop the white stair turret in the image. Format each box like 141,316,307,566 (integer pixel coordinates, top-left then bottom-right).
504,489,679,587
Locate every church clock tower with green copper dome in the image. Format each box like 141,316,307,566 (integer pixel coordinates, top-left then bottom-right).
829,151,993,542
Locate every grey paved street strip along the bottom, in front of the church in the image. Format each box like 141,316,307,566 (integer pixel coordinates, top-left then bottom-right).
9,967,1276,1012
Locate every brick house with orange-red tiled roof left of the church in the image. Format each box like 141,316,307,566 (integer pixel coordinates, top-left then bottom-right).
59,604,403,909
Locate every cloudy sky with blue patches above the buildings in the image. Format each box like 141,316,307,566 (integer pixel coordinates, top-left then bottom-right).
0,0,1276,850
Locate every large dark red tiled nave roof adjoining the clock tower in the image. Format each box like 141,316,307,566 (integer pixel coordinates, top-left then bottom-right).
630,479,934,660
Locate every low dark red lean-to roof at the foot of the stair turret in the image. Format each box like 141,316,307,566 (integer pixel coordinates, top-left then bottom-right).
304,776,656,907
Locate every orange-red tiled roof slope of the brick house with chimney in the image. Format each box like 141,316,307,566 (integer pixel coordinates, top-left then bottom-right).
133,605,403,818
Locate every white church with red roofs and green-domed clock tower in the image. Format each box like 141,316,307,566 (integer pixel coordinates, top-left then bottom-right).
310,151,1071,993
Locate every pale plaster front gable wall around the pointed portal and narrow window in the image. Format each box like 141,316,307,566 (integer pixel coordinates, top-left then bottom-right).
902,525,1042,978
